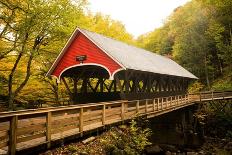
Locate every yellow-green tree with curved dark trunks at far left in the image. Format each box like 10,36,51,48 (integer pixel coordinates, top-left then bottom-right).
1,0,87,110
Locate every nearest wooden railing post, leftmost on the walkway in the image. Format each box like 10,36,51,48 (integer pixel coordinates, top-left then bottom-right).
8,115,18,155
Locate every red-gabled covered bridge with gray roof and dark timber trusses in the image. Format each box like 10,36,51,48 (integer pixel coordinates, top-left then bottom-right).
47,28,197,103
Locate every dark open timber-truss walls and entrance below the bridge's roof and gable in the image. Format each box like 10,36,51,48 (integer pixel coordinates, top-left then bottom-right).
61,65,189,104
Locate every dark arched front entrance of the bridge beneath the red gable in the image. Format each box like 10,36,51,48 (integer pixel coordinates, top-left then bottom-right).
62,65,121,103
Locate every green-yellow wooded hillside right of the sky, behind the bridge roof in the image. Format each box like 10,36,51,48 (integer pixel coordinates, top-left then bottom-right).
137,0,232,89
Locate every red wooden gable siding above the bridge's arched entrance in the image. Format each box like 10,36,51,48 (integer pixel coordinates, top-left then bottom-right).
52,32,122,77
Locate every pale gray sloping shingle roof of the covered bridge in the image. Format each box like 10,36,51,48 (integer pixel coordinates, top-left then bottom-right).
78,28,197,79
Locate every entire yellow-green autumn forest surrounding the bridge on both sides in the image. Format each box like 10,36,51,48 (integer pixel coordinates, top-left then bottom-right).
0,0,232,109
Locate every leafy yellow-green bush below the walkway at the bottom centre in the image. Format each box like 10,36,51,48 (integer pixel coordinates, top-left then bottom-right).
101,120,151,155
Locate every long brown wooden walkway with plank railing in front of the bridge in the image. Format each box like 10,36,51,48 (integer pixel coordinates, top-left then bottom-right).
0,91,232,154
